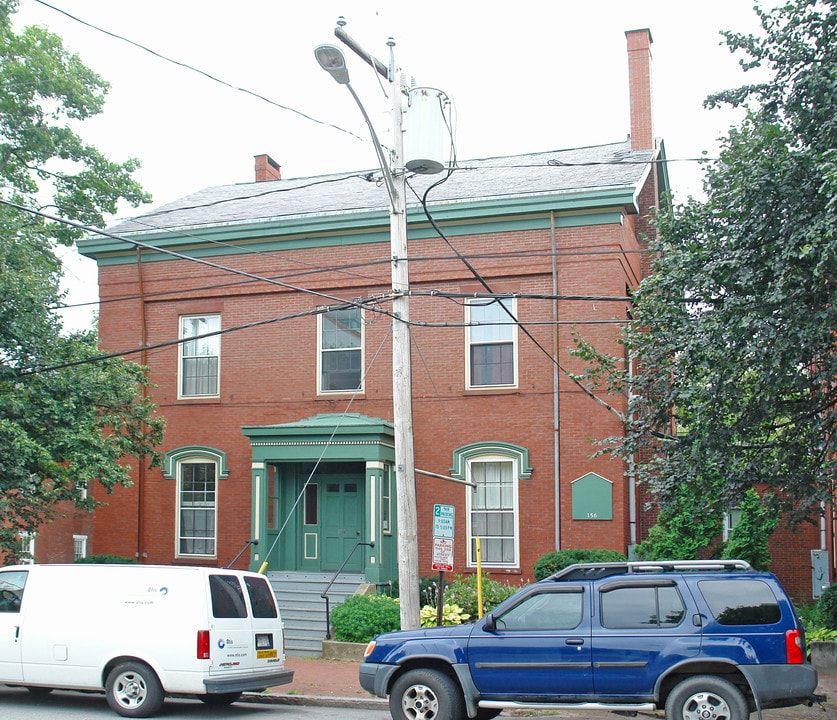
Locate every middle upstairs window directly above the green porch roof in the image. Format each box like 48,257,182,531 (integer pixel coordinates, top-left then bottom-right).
318,307,363,393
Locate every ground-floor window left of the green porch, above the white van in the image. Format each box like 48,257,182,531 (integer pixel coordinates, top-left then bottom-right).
177,461,218,557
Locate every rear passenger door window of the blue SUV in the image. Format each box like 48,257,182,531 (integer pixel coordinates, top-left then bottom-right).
601,585,686,628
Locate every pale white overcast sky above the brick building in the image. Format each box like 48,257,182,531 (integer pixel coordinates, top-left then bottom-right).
9,0,777,327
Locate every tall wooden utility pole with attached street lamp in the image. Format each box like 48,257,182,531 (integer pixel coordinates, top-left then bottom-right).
314,28,420,630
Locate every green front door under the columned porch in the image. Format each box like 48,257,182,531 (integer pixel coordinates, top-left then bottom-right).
316,472,364,571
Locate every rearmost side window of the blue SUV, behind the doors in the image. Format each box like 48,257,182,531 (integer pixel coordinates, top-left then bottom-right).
698,578,782,625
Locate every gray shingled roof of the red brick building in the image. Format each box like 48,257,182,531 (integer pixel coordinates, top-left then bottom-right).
110,139,655,233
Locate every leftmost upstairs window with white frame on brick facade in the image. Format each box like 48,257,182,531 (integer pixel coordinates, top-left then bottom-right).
180,315,221,398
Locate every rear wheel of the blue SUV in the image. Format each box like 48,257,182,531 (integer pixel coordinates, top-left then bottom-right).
666,675,750,720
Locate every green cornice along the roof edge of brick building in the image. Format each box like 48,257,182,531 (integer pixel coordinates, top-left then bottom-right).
78,187,636,265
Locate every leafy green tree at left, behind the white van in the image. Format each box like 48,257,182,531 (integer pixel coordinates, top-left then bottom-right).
0,0,164,560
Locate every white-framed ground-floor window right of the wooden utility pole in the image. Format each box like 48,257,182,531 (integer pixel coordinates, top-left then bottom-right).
468,458,518,567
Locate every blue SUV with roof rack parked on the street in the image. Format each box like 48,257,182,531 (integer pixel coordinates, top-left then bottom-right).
360,560,823,720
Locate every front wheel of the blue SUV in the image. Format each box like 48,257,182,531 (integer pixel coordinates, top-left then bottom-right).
389,669,465,720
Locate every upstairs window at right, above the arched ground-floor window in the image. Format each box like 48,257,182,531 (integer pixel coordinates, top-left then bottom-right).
465,298,517,388
